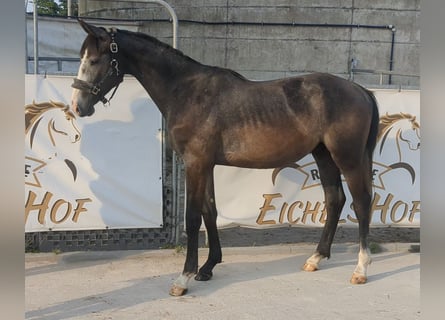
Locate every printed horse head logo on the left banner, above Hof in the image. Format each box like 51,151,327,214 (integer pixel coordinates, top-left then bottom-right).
25,101,81,180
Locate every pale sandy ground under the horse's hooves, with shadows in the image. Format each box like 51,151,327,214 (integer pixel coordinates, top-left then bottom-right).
25,243,420,320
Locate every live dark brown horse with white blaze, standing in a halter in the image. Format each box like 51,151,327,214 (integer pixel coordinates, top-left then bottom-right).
71,20,379,296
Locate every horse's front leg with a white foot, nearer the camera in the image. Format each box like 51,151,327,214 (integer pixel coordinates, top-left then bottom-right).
170,164,207,296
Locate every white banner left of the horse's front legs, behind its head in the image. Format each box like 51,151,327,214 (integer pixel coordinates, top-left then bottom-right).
25,75,163,232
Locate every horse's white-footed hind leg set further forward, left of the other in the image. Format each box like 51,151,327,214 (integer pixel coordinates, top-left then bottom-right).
303,144,346,271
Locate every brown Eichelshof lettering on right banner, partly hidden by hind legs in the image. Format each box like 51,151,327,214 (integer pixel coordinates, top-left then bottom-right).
256,193,420,225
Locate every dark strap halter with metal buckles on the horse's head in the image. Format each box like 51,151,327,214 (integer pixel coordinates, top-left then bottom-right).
71,28,123,105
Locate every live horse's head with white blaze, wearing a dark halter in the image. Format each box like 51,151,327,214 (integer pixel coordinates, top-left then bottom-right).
71,20,123,117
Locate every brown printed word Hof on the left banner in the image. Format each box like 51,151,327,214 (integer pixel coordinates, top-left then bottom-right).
25,190,92,225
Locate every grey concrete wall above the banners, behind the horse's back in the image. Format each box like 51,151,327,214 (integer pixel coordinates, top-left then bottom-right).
79,0,420,87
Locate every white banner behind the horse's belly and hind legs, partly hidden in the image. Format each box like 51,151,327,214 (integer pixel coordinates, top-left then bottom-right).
215,90,420,228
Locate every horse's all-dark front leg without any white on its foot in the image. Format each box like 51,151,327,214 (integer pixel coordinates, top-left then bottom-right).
195,169,222,281
